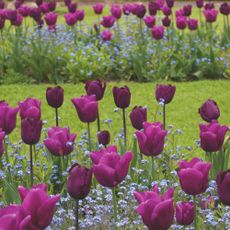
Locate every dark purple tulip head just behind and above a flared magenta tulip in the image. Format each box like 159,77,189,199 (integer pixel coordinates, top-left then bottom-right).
85,79,106,101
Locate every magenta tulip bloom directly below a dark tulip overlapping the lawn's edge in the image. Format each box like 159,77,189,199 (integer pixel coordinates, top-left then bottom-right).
72,95,98,123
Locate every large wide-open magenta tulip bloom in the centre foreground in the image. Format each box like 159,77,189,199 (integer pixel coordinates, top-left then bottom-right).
90,146,133,188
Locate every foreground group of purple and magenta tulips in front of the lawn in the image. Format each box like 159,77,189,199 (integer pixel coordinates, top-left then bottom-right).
0,80,230,230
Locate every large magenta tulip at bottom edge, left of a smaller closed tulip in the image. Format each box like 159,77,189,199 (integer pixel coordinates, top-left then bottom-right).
134,186,174,230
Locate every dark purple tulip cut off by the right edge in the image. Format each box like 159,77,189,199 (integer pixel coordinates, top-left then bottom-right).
216,170,230,206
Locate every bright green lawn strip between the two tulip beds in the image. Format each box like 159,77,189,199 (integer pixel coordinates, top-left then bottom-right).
0,80,230,149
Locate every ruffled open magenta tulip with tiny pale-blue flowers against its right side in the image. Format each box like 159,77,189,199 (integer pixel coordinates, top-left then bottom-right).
43,127,76,156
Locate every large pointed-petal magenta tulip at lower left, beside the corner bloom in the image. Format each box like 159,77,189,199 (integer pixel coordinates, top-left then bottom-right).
18,184,60,229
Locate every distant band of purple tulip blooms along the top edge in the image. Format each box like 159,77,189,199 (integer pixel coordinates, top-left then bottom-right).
0,0,230,41
